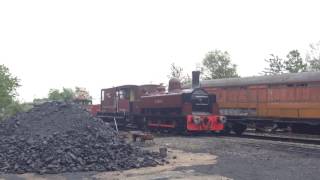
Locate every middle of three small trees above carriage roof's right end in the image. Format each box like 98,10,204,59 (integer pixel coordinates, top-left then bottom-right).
284,50,307,73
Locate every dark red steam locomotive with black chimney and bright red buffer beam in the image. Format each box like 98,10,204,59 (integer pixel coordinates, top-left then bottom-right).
97,71,226,132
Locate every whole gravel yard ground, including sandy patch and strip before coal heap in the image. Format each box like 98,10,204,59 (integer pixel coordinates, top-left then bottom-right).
0,136,320,180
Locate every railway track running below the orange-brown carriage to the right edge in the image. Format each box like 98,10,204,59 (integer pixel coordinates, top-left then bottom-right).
154,129,320,158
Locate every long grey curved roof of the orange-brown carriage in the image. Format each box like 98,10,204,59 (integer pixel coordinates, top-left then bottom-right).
185,72,320,88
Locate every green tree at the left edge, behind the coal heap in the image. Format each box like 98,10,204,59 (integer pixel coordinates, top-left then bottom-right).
0,65,20,120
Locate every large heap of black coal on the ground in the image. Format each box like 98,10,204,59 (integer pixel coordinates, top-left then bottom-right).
0,102,163,173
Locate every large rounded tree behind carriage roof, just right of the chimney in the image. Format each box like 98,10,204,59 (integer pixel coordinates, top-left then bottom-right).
201,50,239,79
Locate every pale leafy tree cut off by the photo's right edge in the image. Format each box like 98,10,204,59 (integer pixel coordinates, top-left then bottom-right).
306,41,320,71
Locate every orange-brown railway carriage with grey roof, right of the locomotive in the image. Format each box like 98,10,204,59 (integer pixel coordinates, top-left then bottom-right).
201,72,320,134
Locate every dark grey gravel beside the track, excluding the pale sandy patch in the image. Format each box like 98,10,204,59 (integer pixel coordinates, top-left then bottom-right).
156,137,320,180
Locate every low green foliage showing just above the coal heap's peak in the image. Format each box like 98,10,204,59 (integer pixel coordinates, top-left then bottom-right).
48,88,75,101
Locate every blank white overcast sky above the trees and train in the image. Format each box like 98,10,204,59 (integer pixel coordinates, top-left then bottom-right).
0,0,320,103
